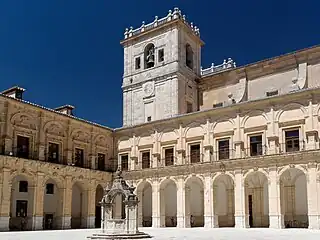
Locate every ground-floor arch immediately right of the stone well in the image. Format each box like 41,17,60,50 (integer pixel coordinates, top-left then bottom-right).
137,181,152,227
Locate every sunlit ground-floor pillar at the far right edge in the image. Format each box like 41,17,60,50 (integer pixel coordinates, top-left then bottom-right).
307,164,320,229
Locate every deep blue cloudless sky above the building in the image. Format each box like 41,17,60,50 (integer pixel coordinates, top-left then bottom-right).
0,0,320,127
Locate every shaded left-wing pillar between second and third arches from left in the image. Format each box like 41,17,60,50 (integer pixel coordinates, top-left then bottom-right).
60,176,72,229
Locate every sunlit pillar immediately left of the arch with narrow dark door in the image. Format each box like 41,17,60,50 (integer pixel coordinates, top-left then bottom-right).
234,170,249,228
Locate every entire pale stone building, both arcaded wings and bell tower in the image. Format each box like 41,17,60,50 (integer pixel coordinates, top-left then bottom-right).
0,9,320,230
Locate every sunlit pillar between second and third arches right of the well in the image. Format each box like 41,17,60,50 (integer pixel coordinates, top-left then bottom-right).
177,178,186,228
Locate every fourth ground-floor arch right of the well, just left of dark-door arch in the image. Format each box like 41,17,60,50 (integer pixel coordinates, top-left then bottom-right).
213,174,235,227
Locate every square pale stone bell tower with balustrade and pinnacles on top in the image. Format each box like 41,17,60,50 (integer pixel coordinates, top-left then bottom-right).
121,8,203,126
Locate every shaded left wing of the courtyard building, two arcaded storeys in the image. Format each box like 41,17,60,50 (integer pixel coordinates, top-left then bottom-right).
0,94,114,230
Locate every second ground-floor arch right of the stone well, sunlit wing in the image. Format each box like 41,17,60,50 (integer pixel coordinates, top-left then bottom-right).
160,179,177,227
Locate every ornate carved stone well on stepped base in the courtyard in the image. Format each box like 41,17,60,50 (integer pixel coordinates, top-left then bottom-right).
87,169,151,240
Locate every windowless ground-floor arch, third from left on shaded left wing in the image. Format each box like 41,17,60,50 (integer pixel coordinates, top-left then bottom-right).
71,183,87,228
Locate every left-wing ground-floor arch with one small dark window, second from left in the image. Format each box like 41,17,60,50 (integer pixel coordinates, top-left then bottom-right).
43,179,62,230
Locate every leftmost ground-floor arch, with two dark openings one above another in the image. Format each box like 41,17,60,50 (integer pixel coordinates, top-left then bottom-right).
9,175,34,230
